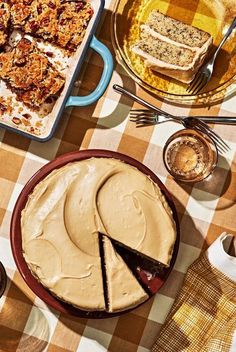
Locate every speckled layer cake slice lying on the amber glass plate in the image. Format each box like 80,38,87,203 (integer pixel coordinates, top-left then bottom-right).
131,10,213,83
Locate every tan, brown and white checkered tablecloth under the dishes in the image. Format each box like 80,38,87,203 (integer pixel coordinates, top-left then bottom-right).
0,2,236,352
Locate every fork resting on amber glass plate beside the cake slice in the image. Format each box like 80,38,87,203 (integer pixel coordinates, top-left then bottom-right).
187,17,236,94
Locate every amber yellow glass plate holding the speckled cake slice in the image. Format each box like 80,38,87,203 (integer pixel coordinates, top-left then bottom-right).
112,0,236,105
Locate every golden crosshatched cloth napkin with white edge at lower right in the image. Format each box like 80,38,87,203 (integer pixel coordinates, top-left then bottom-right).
152,248,236,352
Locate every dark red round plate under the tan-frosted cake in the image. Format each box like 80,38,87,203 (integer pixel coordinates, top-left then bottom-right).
10,149,180,319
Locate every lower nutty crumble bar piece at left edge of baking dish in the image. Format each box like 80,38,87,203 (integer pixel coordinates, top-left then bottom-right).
0,38,65,109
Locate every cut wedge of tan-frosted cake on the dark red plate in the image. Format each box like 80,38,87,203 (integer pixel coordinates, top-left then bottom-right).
103,236,149,312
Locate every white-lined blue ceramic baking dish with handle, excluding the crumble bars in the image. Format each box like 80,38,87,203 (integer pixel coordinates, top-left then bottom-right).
0,0,113,142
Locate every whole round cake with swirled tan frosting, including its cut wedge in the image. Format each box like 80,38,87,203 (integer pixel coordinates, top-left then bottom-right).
21,158,176,311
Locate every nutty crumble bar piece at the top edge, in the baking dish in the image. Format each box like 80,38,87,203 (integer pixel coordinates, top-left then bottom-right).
11,0,93,51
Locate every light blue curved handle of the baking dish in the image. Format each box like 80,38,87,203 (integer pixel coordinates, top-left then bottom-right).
66,36,113,107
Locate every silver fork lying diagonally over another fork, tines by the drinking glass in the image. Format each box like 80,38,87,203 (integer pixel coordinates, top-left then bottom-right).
113,84,230,153
